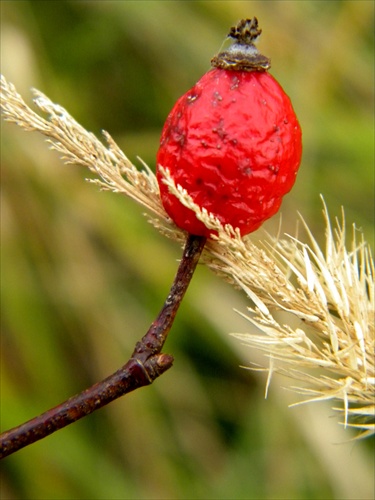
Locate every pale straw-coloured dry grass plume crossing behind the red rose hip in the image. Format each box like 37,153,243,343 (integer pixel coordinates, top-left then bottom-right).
1,77,375,436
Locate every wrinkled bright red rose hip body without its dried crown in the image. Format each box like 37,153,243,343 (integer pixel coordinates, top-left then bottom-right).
156,68,302,237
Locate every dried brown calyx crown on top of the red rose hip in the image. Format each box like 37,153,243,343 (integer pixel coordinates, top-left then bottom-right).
211,17,271,71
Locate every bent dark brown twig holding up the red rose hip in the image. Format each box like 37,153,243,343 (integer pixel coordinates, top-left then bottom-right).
0,235,206,458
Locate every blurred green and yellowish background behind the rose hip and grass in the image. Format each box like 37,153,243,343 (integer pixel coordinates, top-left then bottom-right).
0,0,374,500
